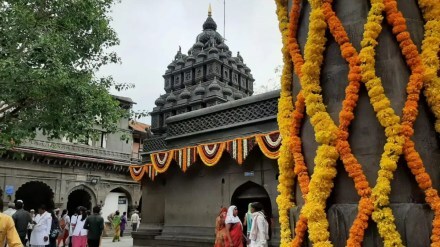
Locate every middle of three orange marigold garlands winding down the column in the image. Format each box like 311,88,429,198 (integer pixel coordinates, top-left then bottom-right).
323,0,373,246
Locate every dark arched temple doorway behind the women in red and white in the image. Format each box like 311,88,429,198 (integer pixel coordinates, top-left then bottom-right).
231,181,272,236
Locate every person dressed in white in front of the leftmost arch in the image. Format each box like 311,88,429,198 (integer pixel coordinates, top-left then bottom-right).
30,205,52,247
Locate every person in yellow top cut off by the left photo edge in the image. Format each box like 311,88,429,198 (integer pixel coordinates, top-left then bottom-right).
0,200,23,247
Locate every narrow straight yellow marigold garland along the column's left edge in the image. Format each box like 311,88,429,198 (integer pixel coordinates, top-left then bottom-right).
276,0,295,247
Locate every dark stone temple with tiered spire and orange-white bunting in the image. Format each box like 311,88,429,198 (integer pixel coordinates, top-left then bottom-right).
130,6,281,246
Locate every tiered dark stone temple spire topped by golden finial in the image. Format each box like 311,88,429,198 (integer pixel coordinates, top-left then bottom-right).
151,3,254,134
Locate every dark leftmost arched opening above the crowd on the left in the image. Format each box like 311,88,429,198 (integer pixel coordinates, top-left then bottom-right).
15,181,55,211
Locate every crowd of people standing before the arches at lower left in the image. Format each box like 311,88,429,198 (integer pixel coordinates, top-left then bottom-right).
0,200,104,247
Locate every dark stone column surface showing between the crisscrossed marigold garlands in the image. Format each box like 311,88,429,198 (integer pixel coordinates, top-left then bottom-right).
289,0,440,246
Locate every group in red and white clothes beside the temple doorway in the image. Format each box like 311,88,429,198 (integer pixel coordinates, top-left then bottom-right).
214,202,269,247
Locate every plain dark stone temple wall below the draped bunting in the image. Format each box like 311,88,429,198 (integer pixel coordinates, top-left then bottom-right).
134,147,279,246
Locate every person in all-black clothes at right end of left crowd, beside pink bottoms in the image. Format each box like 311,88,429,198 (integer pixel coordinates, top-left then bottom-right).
84,206,104,247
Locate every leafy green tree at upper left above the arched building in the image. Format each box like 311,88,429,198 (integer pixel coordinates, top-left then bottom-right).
0,0,139,147
